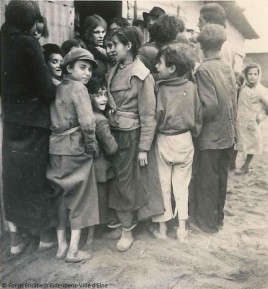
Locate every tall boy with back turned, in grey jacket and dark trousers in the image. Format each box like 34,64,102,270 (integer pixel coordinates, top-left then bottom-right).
195,24,237,233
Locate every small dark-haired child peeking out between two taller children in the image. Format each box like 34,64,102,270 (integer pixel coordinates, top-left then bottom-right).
89,80,118,224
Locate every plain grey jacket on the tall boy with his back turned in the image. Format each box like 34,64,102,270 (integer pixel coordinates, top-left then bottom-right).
195,57,237,150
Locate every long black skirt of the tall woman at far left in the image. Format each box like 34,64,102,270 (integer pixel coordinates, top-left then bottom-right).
2,123,55,229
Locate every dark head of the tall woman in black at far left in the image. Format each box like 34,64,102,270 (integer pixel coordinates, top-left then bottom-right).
5,0,41,30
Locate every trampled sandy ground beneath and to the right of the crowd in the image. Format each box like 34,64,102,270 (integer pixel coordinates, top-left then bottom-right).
0,120,268,289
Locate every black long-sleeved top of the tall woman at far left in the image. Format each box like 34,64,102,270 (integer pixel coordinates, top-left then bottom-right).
1,26,56,128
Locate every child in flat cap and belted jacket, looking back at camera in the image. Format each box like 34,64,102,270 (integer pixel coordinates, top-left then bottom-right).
47,48,99,262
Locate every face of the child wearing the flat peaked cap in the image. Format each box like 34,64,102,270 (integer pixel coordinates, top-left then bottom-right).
67,60,92,84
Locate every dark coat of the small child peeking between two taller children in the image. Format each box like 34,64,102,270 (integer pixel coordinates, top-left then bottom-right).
94,110,118,183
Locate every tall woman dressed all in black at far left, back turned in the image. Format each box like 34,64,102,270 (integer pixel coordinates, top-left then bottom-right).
1,0,56,254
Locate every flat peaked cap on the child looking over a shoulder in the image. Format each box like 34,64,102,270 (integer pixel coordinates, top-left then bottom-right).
61,48,98,69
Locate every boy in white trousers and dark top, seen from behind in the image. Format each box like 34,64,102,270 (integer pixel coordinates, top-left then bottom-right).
152,42,202,242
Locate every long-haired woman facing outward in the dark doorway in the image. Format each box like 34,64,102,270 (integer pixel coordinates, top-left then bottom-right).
81,14,107,81
